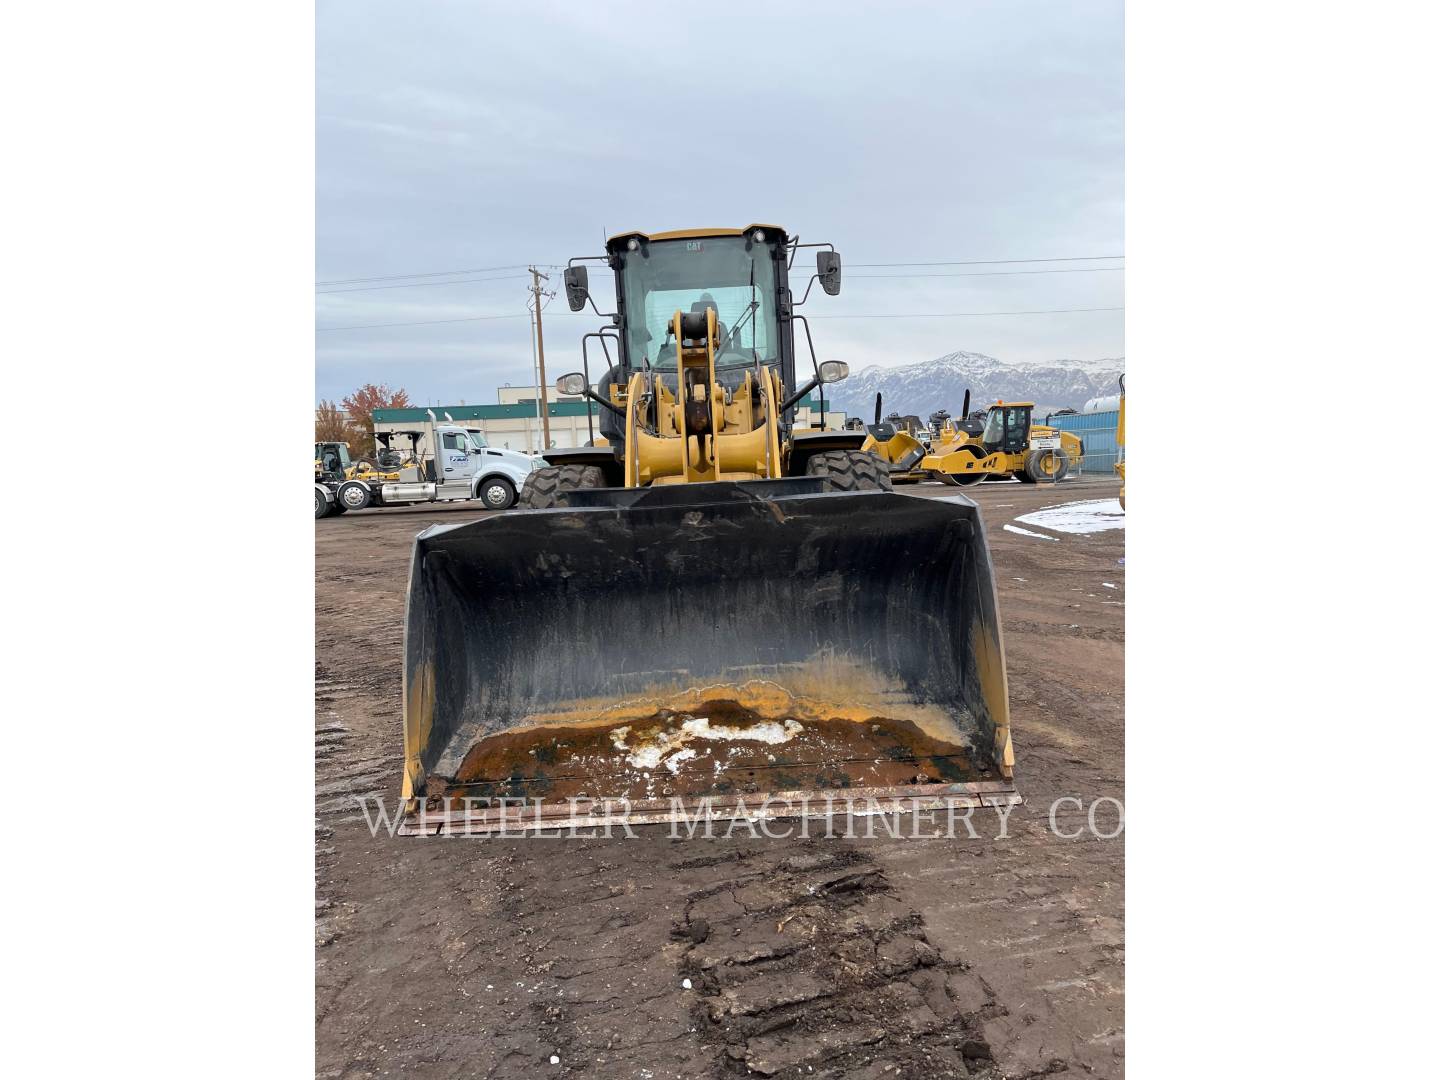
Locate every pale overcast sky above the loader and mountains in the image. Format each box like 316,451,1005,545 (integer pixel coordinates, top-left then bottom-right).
315,0,1125,405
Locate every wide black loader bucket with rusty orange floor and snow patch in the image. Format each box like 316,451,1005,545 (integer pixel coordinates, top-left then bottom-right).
403,480,1018,834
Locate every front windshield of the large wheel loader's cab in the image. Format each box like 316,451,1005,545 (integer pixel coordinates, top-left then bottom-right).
621,236,780,372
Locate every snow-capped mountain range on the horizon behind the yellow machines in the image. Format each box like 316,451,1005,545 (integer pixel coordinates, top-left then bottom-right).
825,351,1125,422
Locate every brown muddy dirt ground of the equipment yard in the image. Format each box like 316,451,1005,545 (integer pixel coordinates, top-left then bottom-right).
315,480,1125,1080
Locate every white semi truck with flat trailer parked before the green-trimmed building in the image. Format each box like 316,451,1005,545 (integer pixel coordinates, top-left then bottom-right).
315,413,546,517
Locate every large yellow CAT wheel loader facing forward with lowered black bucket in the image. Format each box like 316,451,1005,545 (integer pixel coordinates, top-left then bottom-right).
402,225,1020,834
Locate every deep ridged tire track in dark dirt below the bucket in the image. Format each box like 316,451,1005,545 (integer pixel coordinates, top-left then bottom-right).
675,841,995,1077
